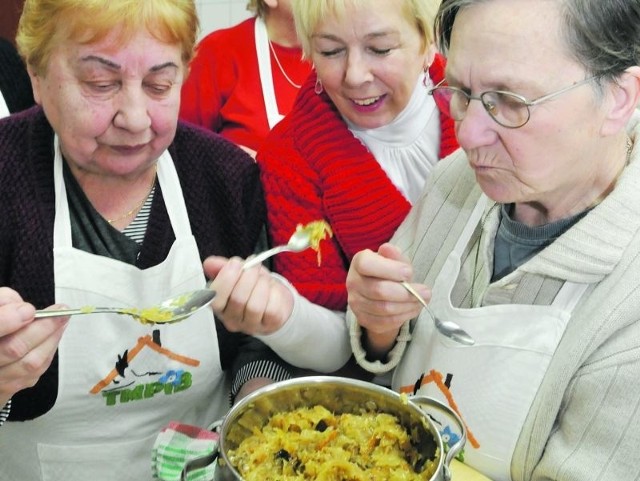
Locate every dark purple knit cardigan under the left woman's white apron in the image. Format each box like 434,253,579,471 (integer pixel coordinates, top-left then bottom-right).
0,107,286,421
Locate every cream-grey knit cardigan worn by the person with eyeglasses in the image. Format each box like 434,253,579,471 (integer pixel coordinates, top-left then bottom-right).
347,110,640,481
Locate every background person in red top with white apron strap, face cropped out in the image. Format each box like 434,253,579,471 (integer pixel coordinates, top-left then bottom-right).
180,0,311,156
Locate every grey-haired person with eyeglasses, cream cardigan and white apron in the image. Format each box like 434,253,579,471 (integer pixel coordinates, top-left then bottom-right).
347,0,640,481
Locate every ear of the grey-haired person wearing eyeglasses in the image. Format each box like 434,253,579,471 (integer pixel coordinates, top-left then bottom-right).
602,66,640,135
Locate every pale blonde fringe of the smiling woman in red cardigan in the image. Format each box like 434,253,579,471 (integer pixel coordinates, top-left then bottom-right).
291,0,440,58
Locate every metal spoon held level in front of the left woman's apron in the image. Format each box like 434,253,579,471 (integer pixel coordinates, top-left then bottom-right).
35,289,216,324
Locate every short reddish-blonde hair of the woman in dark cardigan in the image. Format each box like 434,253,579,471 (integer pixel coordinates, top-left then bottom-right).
16,0,199,73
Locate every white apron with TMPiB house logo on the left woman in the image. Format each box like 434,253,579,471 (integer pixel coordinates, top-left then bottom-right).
0,139,229,481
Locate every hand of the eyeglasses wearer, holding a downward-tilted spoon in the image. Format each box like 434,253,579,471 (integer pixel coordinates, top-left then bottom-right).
347,243,431,352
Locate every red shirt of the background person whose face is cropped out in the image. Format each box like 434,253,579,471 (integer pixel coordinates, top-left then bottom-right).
180,18,311,151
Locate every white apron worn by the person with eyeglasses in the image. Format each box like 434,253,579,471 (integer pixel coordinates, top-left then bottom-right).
393,196,588,481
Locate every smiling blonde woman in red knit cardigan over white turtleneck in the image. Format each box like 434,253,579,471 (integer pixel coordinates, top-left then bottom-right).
205,0,457,378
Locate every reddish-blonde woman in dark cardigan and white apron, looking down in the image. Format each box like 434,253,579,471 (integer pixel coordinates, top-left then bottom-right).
0,0,296,481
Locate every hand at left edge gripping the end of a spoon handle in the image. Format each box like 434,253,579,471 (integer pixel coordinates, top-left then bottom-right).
0,287,69,406
